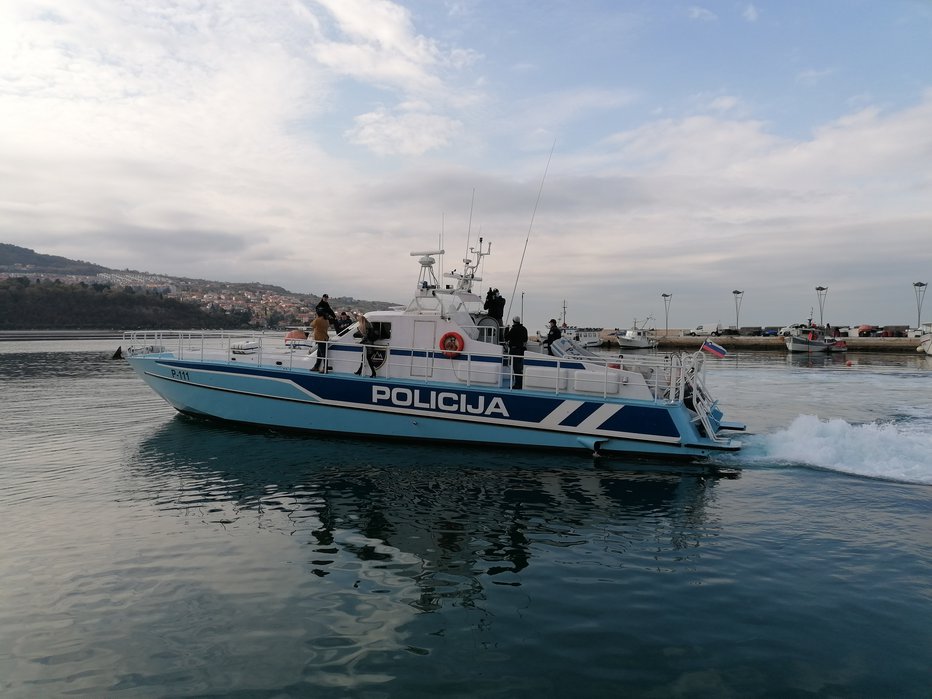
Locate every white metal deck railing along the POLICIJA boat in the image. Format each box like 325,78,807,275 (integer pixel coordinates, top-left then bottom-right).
123,326,716,408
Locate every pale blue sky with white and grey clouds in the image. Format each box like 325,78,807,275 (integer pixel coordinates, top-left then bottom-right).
0,0,932,328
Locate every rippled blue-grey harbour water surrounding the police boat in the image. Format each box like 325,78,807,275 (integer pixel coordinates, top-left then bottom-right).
0,340,932,698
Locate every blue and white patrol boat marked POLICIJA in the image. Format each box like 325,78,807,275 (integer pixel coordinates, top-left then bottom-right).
124,239,744,459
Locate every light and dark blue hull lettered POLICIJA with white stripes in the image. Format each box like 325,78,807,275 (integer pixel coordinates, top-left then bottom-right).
129,354,740,458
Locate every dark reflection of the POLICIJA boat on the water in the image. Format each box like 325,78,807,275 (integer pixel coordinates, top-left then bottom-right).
131,416,739,610
